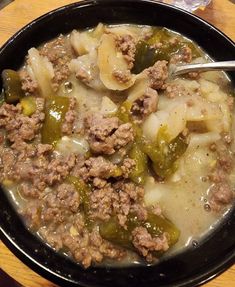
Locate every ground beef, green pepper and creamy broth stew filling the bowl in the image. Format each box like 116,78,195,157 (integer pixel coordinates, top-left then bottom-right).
0,24,235,268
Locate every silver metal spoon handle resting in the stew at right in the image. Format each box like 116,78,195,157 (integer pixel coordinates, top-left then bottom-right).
173,61,235,76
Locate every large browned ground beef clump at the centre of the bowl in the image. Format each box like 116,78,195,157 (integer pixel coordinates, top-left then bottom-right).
85,114,134,154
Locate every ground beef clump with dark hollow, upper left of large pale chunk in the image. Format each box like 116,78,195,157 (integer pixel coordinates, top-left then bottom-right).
131,88,158,122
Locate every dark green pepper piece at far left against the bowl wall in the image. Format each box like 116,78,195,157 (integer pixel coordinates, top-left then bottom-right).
2,69,24,104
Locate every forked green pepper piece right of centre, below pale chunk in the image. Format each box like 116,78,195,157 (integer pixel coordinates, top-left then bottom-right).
143,126,188,178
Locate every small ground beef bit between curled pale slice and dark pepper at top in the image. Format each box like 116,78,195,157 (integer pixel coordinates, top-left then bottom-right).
115,34,136,69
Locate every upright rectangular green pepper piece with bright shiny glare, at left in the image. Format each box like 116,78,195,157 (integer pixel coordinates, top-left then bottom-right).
41,96,69,145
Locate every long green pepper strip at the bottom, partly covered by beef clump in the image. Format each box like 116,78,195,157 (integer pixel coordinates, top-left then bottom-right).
99,212,180,249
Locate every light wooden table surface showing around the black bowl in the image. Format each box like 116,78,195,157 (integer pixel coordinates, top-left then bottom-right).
0,0,235,287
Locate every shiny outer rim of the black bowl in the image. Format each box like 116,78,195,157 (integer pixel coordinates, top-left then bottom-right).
0,0,235,287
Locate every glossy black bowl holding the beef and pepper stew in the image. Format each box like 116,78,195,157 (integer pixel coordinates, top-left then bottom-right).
0,0,235,287
